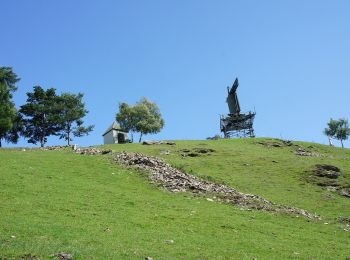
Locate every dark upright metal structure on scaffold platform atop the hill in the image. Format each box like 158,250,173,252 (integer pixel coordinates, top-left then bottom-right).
220,78,256,138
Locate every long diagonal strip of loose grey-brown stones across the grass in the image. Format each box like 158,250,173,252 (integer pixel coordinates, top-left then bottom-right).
115,152,318,219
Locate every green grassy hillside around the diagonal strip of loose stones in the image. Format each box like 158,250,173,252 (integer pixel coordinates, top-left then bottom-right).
0,139,350,259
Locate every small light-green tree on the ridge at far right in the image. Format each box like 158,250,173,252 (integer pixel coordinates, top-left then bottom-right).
324,118,350,148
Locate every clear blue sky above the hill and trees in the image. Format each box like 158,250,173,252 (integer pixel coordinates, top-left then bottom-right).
0,0,350,146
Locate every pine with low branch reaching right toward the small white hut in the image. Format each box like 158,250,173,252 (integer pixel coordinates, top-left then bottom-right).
59,93,94,145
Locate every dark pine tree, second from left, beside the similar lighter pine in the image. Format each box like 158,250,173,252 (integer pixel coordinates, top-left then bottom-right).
19,86,61,147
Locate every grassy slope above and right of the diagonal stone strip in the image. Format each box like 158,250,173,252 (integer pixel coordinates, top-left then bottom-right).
103,138,350,220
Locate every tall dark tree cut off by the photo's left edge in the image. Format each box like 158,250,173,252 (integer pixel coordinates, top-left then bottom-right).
0,67,20,147
